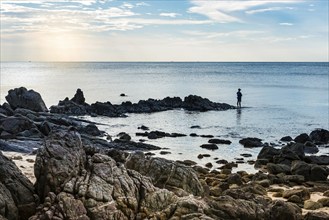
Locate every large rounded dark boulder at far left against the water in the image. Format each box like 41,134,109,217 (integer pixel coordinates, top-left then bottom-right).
6,87,48,112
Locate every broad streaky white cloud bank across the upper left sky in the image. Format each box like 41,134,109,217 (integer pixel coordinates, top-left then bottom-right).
1,0,212,35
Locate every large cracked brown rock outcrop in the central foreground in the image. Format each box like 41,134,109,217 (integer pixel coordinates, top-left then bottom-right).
30,131,301,220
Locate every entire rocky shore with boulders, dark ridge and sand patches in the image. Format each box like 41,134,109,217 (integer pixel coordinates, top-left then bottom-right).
0,88,329,220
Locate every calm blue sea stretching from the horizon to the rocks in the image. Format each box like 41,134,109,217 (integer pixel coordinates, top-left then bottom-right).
0,62,329,172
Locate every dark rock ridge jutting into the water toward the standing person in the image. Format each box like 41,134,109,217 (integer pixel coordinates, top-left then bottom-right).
50,89,235,117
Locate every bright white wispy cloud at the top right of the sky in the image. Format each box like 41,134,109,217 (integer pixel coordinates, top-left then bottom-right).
188,0,301,23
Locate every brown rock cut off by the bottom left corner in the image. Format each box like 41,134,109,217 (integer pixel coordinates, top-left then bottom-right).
0,152,39,219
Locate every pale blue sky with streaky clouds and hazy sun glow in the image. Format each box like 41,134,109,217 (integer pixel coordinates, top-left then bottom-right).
0,0,329,62
